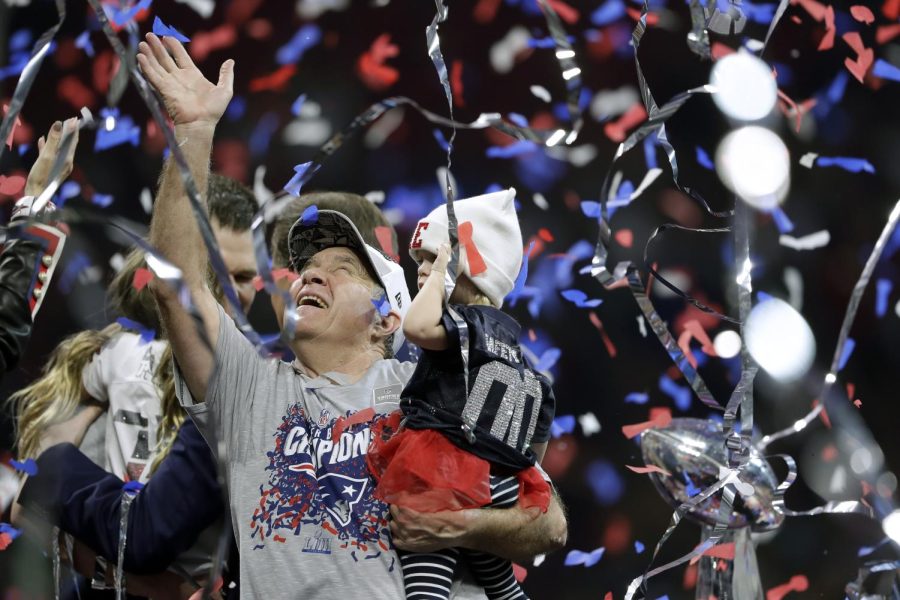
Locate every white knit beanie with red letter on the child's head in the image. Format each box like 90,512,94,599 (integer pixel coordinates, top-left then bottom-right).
409,188,522,308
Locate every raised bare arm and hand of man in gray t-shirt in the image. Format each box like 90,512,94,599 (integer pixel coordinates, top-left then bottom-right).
137,33,234,401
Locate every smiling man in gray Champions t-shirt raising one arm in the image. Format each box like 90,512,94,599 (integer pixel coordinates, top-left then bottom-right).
138,34,566,599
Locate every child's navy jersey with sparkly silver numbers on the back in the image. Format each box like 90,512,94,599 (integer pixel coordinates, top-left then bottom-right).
401,304,556,470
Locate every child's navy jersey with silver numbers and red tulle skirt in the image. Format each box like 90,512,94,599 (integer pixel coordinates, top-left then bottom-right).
368,305,555,512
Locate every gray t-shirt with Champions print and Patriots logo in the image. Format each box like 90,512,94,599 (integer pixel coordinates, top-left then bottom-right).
176,307,485,600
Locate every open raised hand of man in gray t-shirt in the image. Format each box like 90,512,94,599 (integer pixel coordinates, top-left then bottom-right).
137,33,234,128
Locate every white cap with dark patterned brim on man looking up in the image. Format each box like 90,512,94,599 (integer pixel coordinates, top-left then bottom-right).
288,210,411,354
